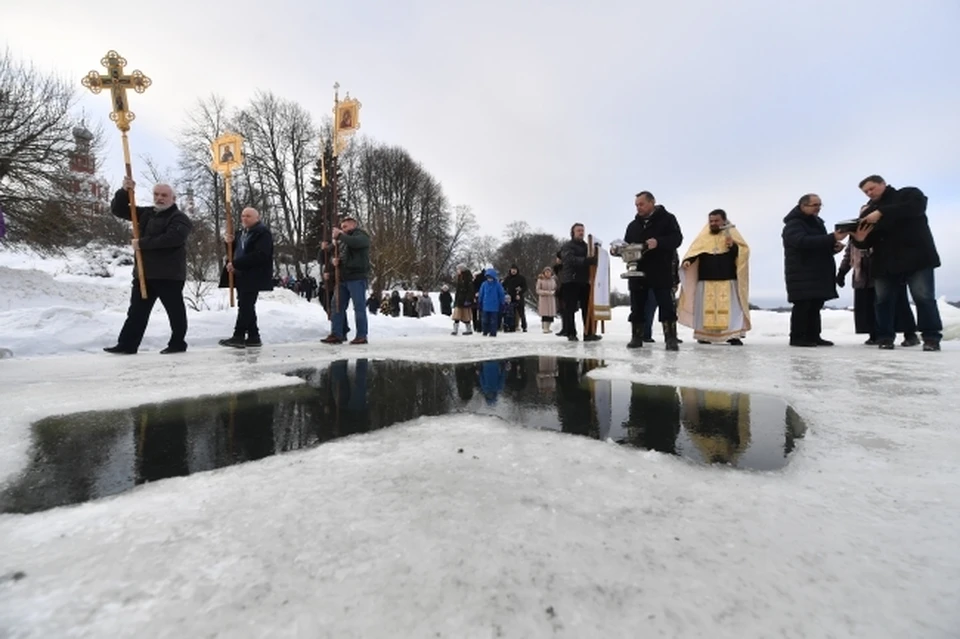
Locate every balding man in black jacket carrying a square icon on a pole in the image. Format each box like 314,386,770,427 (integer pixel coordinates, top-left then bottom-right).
220,207,273,348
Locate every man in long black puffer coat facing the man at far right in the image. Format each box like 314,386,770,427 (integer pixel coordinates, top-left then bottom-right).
780,193,847,346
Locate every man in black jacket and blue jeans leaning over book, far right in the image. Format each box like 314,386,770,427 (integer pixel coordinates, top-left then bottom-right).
853,175,943,351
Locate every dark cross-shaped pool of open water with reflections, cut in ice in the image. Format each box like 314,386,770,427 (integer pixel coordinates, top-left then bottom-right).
0,357,804,513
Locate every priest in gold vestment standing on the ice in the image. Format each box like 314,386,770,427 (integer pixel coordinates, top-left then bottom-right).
677,209,750,346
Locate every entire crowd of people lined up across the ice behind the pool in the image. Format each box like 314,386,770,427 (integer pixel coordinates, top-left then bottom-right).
104,175,942,354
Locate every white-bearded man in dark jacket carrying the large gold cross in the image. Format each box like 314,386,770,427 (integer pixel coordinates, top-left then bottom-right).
103,178,193,355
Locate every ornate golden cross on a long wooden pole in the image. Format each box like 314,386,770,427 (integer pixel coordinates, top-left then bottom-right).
82,51,152,299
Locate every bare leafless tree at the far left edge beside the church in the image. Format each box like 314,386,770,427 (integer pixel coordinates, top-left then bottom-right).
0,50,76,246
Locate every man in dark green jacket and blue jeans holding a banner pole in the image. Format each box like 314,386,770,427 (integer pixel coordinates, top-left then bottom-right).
320,215,370,344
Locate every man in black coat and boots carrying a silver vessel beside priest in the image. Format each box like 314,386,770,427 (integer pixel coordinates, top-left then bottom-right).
623,191,683,351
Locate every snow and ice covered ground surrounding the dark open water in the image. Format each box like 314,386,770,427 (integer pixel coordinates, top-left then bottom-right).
0,242,960,638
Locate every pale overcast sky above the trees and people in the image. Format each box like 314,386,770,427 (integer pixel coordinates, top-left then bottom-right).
0,0,960,304
